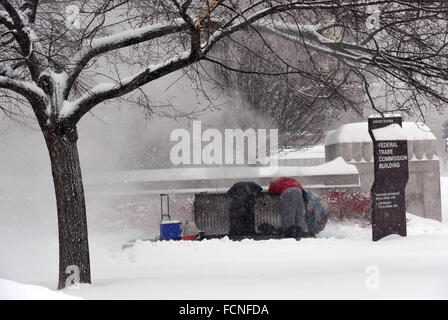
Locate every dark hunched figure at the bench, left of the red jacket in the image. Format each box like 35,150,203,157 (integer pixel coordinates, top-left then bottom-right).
227,181,263,236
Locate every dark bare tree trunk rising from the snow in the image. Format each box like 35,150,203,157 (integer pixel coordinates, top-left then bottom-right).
44,129,91,289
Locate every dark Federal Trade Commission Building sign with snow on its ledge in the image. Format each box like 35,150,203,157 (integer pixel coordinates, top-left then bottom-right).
369,116,409,241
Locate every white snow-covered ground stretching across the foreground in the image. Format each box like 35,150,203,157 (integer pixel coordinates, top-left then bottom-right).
0,177,448,299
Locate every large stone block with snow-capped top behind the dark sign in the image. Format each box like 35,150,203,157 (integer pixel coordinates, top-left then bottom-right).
325,122,442,221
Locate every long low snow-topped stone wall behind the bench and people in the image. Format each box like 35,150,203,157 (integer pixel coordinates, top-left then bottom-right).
84,158,360,195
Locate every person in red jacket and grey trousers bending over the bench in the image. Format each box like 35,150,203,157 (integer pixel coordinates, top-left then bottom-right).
268,177,308,238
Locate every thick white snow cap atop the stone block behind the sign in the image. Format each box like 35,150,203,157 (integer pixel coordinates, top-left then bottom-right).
325,122,436,145
